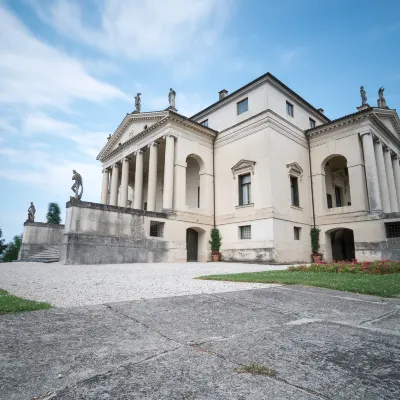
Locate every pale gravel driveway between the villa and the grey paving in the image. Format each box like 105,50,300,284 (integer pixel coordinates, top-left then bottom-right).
0,263,286,307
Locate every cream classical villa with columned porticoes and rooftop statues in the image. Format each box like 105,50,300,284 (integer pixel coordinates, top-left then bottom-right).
19,73,400,264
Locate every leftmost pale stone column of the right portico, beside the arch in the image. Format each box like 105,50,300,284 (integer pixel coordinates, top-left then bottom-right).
360,132,382,212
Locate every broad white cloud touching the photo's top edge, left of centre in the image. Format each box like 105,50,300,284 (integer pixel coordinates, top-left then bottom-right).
31,0,231,60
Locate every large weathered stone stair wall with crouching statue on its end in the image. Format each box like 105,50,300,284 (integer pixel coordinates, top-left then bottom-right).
60,200,168,264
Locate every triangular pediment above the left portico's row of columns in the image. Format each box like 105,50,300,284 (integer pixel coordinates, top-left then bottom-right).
97,111,168,160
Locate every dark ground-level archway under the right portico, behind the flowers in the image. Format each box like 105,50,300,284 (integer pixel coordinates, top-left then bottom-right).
326,228,356,261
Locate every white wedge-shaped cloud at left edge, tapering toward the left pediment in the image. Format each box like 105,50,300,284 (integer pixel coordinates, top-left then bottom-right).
0,5,129,109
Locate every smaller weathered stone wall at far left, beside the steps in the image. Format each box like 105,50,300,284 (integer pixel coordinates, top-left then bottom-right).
18,222,64,260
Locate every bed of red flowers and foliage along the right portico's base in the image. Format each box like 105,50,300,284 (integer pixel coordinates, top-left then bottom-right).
288,260,400,275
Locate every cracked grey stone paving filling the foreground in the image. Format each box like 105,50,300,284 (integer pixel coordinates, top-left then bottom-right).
0,286,400,400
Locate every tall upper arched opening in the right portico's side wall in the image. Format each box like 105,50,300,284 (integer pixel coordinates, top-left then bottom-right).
323,155,351,208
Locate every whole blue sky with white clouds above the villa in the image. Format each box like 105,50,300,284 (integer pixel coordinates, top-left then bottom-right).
0,0,400,239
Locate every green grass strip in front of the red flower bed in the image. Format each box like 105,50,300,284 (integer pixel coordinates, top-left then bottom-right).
197,271,400,297
